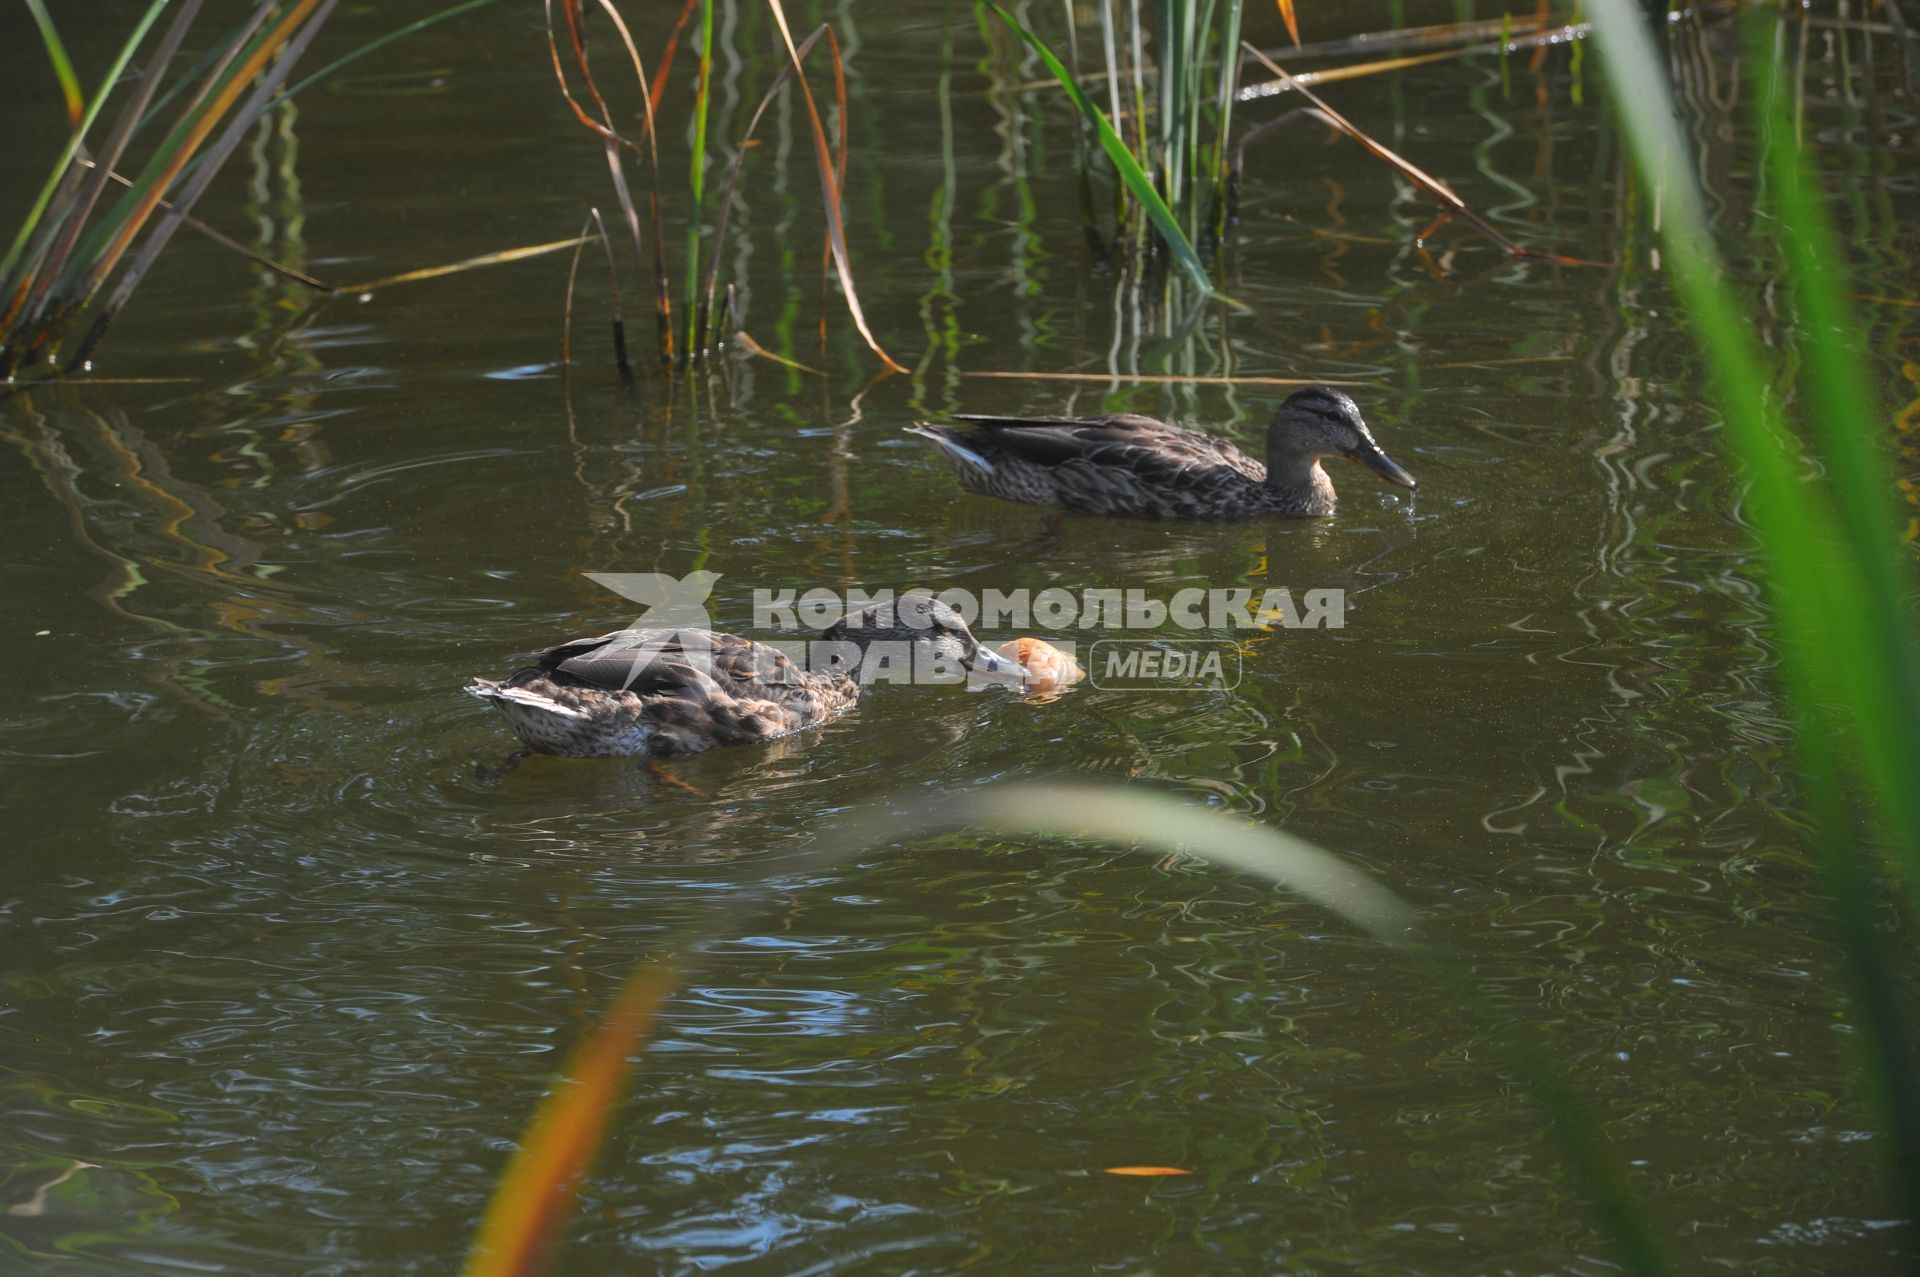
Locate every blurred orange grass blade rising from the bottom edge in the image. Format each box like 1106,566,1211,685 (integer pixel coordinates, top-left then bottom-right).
465,968,670,1277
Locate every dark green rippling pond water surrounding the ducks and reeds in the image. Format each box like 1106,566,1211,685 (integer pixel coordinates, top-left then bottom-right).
0,0,1920,1275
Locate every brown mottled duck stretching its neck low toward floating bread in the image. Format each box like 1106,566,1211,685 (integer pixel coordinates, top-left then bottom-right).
467,593,1023,759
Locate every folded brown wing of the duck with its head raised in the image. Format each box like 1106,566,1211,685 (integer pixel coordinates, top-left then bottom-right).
958,413,1267,488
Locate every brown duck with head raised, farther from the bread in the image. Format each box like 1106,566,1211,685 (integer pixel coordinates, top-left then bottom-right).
906,386,1413,518
